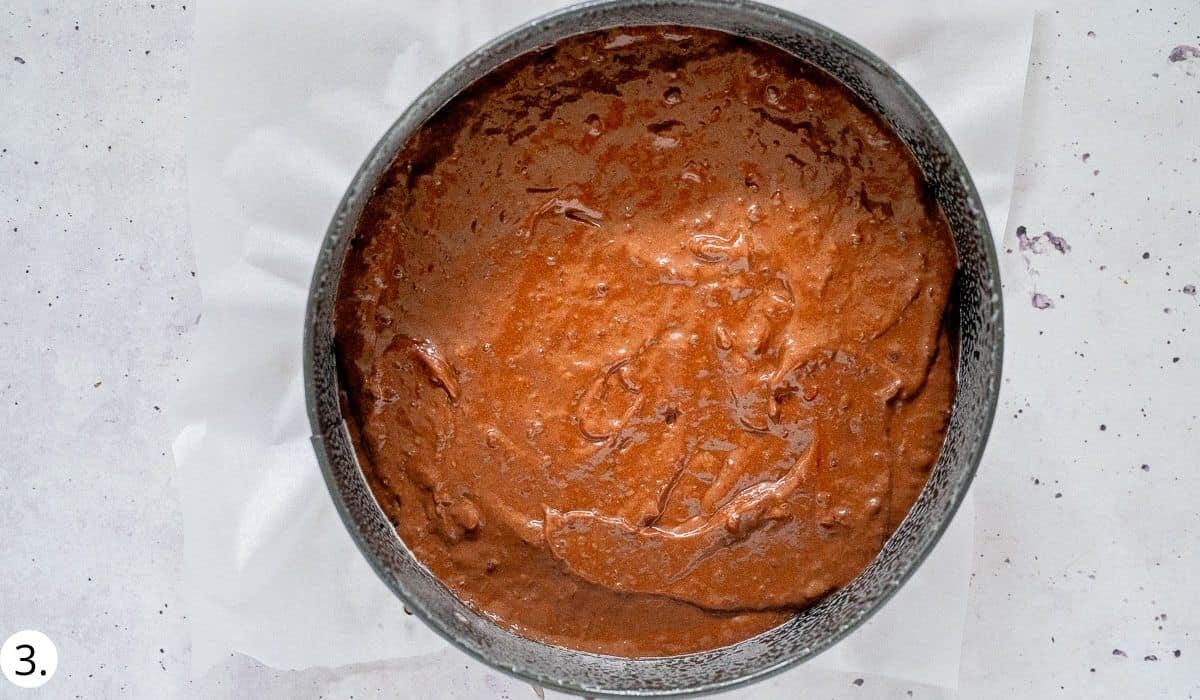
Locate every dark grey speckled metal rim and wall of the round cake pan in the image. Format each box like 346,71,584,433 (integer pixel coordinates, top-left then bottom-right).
304,0,1003,696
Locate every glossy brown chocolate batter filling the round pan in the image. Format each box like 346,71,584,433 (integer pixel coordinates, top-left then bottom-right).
336,26,956,656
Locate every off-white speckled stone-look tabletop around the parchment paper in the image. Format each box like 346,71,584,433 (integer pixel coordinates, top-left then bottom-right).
0,0,1200,699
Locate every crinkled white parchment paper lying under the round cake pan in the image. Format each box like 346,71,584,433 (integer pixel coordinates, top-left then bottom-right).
168,0,1032,688
